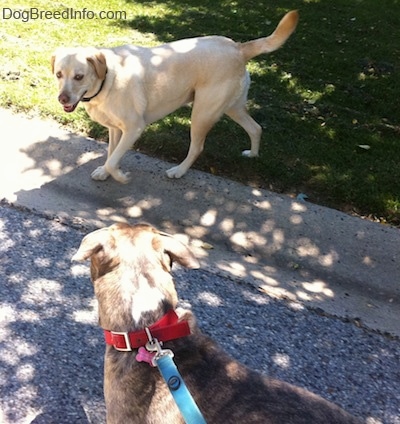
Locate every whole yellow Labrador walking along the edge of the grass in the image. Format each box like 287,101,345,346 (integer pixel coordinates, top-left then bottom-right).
52,11,298,183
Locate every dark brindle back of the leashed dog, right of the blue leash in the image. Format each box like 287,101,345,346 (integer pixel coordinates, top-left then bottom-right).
144,318,361,424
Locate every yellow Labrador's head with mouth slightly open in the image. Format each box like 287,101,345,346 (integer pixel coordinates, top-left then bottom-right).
51,47,107,112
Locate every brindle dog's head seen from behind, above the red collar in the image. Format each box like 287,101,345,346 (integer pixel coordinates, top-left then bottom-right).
72,224,199,331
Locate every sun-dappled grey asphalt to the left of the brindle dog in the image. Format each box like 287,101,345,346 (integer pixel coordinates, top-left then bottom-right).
0,210,105,424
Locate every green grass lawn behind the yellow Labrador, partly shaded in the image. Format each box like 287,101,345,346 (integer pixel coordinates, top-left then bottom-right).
0,0,400,225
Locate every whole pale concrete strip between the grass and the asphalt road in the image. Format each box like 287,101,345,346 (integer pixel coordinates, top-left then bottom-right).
0,109,400,336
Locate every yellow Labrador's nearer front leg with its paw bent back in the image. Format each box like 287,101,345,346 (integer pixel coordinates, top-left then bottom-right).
96,122,145,184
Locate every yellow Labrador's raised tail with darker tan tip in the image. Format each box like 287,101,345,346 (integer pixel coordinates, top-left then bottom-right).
239,10,299,62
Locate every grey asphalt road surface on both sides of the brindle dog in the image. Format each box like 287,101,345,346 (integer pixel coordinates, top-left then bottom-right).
0,205,400,424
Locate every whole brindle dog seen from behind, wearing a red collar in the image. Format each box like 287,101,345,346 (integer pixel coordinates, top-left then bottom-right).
73,224,361,424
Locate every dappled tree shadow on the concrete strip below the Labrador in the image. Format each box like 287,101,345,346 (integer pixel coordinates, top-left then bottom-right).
11,128,397,332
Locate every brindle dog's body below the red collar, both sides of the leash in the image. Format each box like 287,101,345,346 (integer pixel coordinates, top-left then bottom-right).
97,311,361,424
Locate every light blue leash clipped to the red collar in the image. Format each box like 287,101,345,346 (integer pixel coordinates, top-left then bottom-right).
155,354,206,424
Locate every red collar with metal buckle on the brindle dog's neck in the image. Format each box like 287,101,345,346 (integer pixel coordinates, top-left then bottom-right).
104,309,190,352
